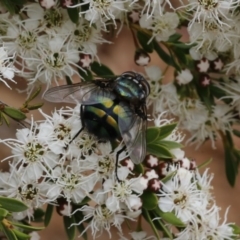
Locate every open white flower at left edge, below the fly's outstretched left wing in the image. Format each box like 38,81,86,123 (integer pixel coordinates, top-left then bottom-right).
1,124,59,181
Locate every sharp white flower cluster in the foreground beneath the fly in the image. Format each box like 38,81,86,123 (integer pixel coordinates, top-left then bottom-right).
0,108,235,239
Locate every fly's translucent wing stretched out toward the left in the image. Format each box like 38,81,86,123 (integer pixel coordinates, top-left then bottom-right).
44,81,116,105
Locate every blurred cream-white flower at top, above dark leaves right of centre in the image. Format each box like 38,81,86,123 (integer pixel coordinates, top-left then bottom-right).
140,12,179,42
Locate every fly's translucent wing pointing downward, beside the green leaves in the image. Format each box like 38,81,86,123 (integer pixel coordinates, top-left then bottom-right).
118,103,147,164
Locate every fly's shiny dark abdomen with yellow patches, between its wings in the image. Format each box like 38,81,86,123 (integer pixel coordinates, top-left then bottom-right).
82,100,121,140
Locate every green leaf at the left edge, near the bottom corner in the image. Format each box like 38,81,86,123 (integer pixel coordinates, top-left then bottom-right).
0,197,28,212
